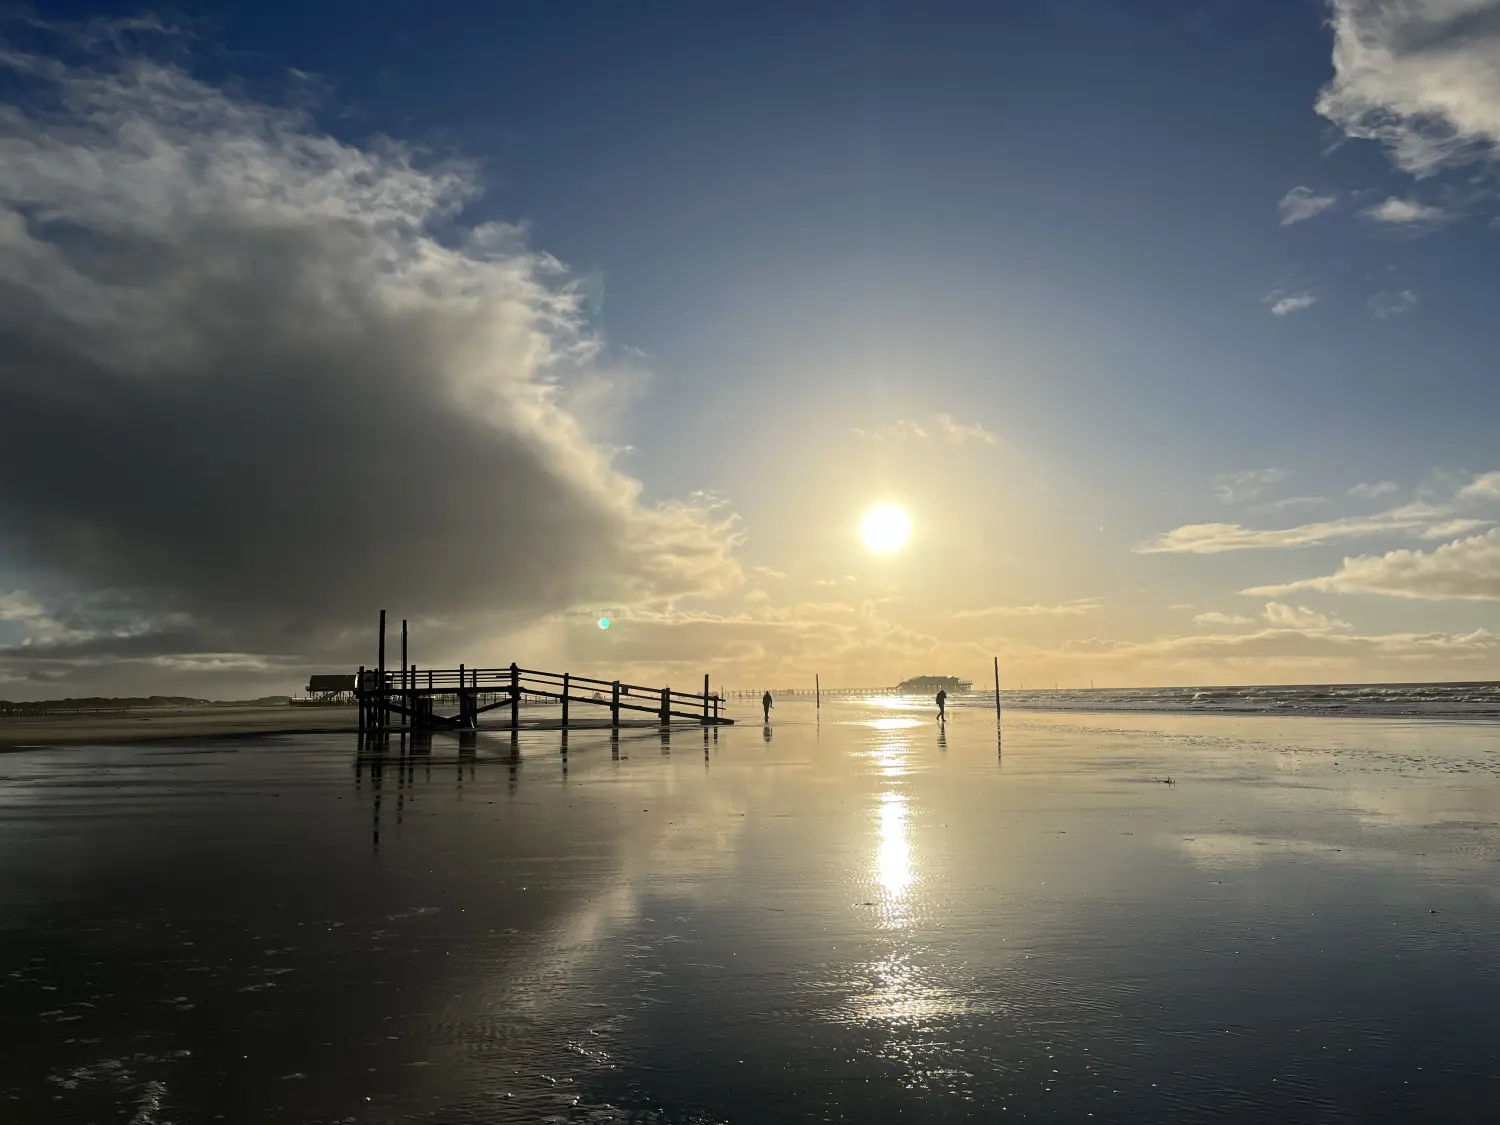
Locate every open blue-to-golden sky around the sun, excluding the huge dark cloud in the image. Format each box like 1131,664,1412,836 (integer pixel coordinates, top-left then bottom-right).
0,0,1500,696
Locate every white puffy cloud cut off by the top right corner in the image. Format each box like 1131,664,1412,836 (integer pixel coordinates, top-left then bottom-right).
1317,0,1500,176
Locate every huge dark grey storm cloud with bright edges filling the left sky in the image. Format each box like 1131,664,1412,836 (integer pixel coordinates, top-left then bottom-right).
0,30,738,678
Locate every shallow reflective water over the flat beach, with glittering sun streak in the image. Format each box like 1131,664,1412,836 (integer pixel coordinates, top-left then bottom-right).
0,702,1500,1125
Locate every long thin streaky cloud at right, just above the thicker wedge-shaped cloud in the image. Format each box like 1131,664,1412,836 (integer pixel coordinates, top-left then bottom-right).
1136,473,1500,555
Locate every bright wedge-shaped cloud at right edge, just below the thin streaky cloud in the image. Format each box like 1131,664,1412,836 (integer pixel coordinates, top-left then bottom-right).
1245,528,1500,602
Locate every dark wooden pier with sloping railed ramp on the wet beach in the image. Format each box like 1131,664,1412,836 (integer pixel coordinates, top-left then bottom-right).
354,611,735,735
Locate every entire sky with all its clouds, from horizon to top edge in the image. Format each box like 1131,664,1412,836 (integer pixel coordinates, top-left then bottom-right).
0,0,1500,699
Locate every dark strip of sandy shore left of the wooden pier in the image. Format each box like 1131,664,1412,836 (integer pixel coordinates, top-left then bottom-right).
0,707,359,750
